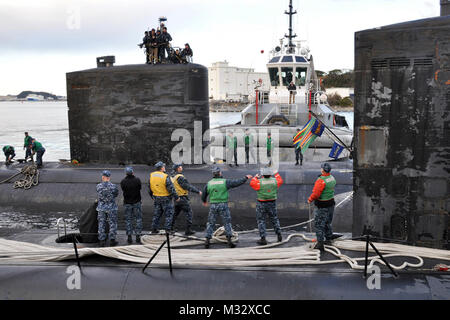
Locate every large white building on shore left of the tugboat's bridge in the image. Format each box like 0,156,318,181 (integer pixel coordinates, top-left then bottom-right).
208,61,270,102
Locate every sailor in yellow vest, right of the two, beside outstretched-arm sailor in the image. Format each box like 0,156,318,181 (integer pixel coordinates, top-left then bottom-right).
172,164,202,236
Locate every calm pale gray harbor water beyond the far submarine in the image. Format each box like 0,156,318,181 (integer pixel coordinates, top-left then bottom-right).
0,101,353,161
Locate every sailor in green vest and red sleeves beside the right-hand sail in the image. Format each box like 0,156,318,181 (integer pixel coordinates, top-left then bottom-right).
308,163,339,252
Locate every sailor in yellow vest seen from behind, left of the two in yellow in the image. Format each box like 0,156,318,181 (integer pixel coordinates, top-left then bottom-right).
149,161,180,233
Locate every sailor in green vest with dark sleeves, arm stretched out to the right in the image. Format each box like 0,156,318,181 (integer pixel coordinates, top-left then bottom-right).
202,167,252,249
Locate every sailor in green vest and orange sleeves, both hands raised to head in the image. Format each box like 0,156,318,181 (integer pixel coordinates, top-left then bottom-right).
250,168,283,245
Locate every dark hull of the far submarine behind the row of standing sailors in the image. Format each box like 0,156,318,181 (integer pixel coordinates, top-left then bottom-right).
0,161,352,232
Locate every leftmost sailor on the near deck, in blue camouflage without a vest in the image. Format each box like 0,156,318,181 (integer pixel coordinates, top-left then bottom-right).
97,170,119,247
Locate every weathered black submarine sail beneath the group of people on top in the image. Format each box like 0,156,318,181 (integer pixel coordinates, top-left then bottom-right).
66,56,209,165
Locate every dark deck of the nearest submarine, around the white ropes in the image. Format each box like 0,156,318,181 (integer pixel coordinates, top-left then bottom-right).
0,230,450,300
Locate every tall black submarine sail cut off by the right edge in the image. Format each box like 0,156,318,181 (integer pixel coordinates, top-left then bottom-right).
352,6,450,248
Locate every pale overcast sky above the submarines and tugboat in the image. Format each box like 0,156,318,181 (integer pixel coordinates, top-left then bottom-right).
0,0,440,95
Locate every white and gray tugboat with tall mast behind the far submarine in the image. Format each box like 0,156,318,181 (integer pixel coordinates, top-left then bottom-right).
211,0,353,161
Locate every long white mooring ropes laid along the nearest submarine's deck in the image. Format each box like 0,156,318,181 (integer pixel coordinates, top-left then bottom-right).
0,230,450,270
